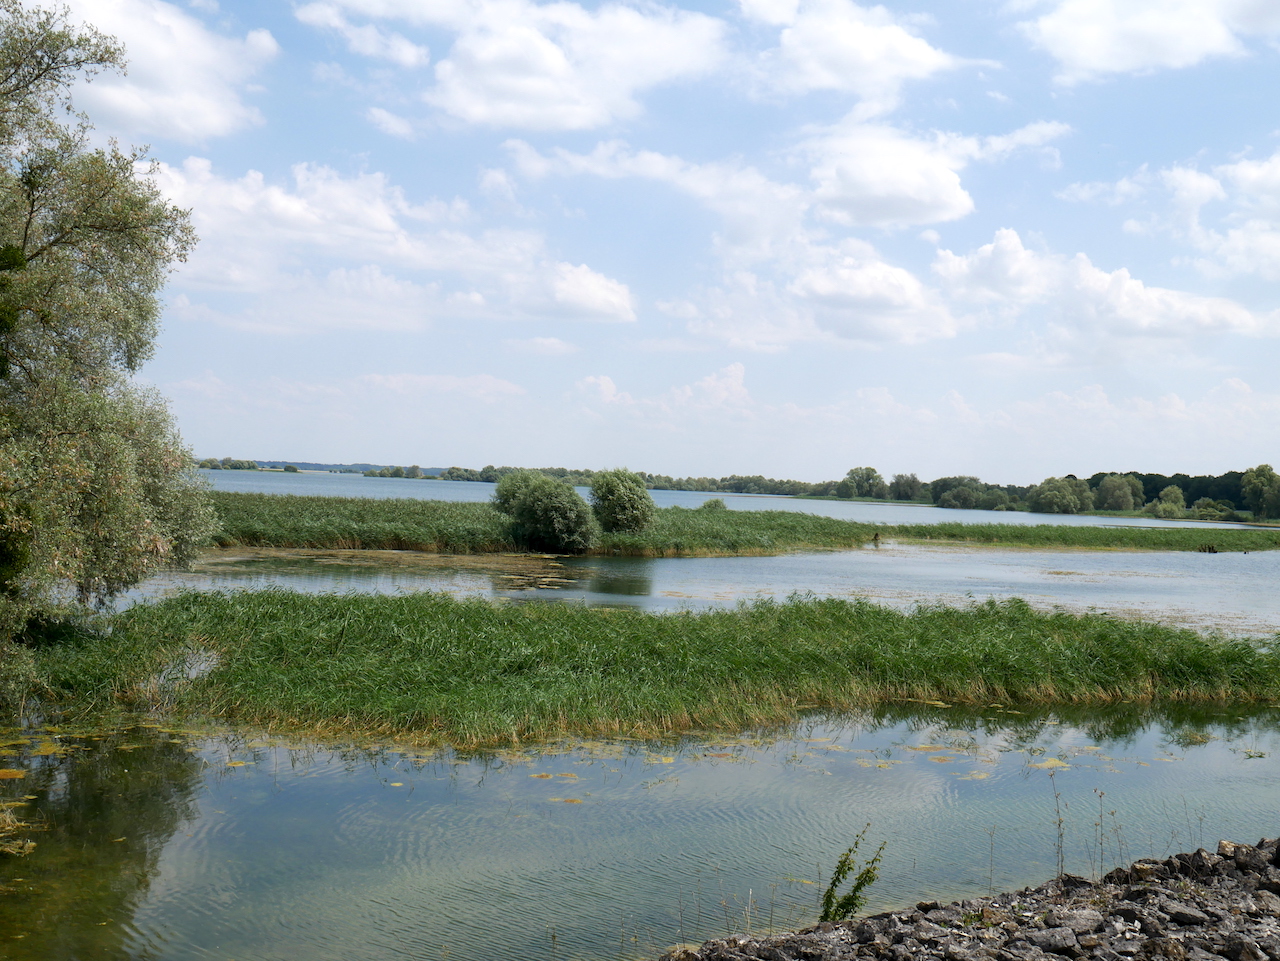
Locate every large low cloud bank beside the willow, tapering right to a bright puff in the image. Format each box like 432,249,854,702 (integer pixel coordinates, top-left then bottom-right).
157,159,635,330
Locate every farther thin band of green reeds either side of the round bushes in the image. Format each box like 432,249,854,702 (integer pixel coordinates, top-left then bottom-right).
212,491,1280,557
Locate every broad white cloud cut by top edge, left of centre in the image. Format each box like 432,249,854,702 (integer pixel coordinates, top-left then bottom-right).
295,0,727,131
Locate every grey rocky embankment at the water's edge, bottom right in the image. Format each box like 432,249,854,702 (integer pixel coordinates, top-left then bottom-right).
663,839,1280,961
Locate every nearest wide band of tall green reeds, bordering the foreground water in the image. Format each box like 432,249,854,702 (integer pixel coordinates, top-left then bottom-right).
37,590,1280,746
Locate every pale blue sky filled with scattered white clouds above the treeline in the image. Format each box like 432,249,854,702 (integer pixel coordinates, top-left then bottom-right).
60,0,1280,484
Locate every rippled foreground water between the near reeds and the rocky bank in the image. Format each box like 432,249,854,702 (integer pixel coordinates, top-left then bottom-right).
0,705,1280,961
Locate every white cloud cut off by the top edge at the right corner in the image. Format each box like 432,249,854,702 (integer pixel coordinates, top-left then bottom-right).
1019,0,1280,83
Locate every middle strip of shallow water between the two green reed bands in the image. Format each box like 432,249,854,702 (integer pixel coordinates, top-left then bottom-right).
125,541,1280,636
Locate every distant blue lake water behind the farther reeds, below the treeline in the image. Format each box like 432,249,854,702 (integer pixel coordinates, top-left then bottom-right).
200,471,1245,527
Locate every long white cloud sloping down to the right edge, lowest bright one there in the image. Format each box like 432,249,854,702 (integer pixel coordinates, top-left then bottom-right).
933,229,1280,337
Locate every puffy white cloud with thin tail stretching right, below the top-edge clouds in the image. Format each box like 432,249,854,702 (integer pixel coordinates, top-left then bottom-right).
800,119,1071,226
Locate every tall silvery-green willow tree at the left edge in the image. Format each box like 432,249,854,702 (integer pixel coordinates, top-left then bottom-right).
0,0,211,641
